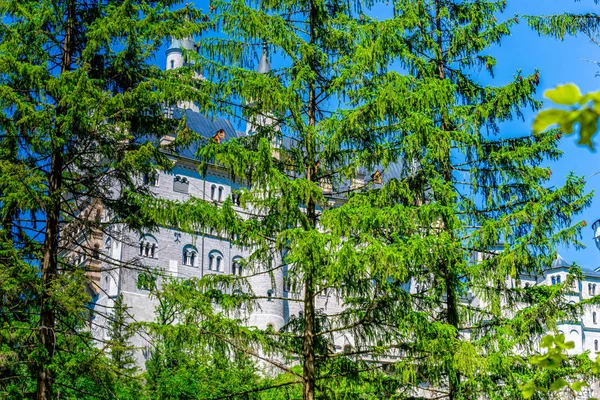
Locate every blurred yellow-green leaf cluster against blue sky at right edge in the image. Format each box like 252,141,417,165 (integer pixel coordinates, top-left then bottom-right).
533,84,600,150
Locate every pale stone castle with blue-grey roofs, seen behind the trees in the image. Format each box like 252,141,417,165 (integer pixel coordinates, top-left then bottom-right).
82,39,600,395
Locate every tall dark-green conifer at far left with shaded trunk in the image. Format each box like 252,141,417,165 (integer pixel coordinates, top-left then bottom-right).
0,0,206,400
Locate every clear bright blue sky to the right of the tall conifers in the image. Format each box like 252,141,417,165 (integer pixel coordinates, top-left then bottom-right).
177,0,600,269
